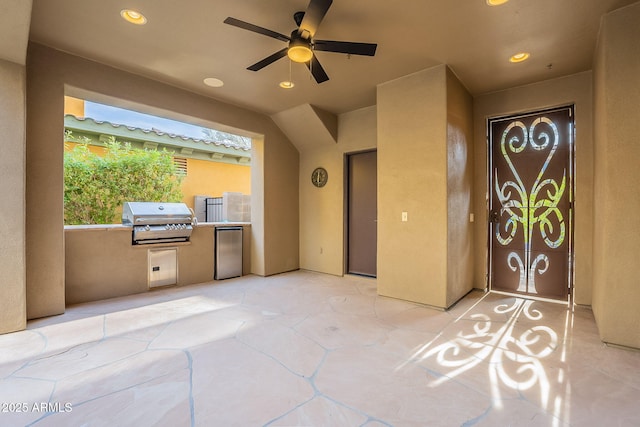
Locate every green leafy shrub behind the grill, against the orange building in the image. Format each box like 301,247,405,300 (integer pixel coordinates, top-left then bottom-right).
64,135,182,225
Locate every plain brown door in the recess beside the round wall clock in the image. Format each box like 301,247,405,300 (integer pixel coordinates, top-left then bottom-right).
347,151,378,277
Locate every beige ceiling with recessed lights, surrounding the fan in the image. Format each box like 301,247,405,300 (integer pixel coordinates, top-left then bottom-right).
13,0,637,115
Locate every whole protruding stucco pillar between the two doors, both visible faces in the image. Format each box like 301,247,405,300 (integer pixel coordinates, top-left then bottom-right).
377,65,474,308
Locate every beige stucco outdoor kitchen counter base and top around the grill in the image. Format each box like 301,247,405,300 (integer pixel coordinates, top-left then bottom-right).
64,222,251,304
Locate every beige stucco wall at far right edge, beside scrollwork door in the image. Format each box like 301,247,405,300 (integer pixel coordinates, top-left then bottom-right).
593,3,640,348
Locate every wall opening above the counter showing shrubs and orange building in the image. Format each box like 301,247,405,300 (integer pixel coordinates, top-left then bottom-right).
64,96,252,225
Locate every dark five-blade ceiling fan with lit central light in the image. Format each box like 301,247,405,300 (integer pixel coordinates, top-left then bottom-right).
224,0,378,83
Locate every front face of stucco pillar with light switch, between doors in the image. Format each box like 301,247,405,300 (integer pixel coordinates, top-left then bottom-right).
377,65,448,307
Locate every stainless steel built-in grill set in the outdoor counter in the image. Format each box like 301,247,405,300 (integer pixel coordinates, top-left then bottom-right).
122,202,195,245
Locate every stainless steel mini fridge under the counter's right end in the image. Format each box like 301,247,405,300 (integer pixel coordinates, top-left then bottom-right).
213,226,242,280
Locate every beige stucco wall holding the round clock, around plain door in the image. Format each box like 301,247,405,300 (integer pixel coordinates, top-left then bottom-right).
300,106,376,275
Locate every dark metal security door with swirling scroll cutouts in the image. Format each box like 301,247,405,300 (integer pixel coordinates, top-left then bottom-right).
489,106,573,299
